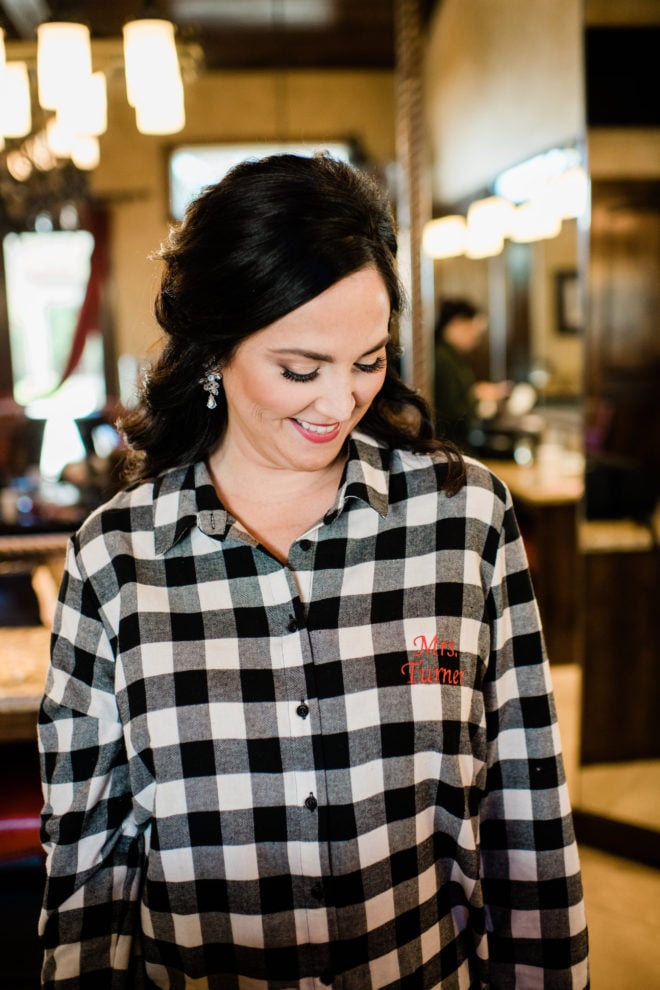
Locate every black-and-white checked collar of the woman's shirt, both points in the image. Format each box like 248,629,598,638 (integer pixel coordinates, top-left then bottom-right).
153,431,390,556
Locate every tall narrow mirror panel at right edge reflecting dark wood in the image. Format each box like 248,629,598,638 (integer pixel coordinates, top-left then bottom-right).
579,17,660,866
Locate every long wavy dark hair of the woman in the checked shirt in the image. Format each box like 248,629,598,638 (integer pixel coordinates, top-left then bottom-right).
121,155,463,491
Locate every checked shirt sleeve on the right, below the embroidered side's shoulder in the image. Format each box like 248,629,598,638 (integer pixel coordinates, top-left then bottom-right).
480,492,589,990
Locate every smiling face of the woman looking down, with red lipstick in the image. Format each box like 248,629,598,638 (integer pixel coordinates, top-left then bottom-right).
220,268,390,471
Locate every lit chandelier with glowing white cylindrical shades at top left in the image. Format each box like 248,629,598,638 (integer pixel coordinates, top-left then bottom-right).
0,18,196,169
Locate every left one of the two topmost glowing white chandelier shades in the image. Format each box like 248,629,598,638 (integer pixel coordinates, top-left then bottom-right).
37,21,92,110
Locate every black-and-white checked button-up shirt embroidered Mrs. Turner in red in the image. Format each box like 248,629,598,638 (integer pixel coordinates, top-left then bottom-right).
40,433,588,990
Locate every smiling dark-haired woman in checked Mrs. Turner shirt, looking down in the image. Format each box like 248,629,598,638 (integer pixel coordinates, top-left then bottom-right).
40,156,587,990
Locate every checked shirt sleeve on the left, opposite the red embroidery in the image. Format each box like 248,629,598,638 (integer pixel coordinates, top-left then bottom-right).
39,544,149,990
